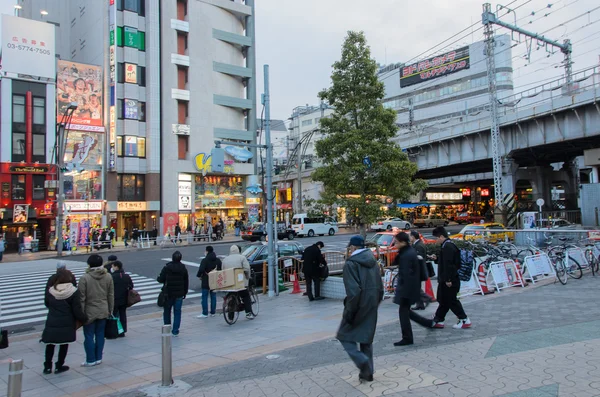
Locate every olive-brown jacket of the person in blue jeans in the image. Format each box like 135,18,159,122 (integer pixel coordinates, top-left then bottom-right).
79,266,115,324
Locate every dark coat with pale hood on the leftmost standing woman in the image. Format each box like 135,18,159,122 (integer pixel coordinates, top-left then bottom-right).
42,283,86,345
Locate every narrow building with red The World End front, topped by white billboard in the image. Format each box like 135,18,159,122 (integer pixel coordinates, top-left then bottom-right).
0,15,57,251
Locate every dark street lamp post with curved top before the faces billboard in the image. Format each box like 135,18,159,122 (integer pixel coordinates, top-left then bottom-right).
55,102,77,256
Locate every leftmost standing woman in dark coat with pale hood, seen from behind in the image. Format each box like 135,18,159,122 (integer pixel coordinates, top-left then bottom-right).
42,269,86,374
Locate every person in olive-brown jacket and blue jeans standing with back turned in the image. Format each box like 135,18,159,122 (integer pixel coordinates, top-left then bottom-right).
79,254,115,367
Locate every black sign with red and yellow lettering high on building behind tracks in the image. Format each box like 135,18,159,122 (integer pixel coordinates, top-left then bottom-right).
400,46,470,87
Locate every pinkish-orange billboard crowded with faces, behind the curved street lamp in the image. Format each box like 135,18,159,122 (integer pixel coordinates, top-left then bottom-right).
56,60,104,128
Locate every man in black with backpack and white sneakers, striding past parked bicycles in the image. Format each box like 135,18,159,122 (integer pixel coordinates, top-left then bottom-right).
432,226,471,329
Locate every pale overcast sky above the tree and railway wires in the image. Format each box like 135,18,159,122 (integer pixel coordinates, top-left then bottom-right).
256,0,600,119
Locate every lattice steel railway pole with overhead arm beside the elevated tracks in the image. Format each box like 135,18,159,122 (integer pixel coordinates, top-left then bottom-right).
481,3,573,212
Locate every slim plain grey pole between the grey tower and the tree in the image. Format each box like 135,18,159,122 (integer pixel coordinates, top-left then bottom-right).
263,65,277,297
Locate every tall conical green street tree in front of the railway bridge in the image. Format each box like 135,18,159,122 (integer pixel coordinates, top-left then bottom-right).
312,31,426,237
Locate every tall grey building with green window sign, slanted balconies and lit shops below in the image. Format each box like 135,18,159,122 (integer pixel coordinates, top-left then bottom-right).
22,0,259,236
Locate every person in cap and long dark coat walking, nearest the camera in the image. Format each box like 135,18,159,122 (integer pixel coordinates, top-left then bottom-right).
336,236,383,382
